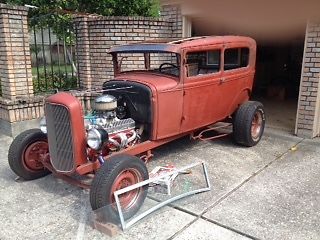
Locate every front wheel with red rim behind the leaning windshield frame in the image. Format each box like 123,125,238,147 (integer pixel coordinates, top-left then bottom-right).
90,155,149,224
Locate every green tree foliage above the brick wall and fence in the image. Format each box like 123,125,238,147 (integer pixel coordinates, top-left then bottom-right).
0,0,160,35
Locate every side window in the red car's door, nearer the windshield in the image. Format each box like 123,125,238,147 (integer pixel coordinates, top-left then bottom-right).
186,49,221,77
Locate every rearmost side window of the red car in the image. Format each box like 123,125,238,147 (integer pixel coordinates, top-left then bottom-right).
224,48,249,70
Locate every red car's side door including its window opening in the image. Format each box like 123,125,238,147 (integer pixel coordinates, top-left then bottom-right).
181,45,223,132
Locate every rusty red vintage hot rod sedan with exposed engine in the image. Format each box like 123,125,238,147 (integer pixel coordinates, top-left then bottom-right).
8,36,265,222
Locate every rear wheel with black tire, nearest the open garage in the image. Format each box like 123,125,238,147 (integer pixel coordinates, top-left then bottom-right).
233,101,265,147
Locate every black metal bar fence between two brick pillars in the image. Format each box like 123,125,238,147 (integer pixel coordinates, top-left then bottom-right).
30,19,79,93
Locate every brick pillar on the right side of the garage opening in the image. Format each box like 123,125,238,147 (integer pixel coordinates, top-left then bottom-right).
296,23,320,138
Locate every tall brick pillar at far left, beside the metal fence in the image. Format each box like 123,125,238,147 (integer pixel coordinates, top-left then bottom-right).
0,4,33,99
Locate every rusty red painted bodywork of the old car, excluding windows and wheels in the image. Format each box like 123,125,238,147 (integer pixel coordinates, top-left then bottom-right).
43,36,256,175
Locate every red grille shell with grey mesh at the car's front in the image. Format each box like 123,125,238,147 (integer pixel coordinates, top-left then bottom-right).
45,92,90,175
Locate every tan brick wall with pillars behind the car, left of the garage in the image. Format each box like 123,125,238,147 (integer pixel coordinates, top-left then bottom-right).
0,4,182,135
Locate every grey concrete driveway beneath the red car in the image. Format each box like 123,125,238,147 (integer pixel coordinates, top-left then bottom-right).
0,129,320,240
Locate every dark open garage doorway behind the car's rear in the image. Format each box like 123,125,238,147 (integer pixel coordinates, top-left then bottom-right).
252,37,304,133
